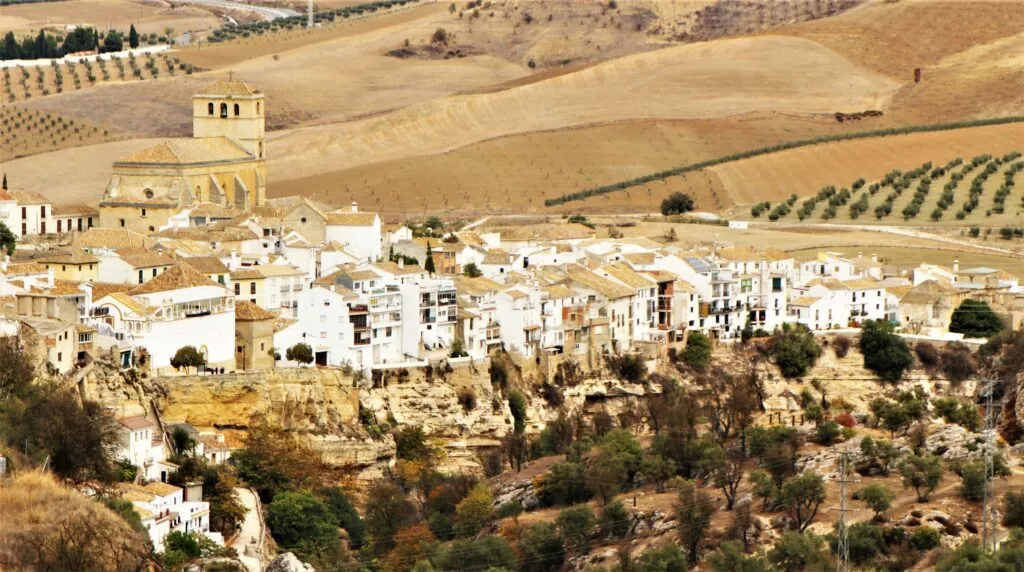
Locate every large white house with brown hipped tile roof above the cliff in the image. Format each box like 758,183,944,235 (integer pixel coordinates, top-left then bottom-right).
91,264,234,373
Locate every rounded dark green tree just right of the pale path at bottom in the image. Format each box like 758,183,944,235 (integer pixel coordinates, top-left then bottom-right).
266,492,338,560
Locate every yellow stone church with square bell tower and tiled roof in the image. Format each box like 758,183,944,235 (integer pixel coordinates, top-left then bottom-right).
99,81,266,233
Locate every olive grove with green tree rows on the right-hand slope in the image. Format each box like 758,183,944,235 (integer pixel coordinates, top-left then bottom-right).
744,151,1024,228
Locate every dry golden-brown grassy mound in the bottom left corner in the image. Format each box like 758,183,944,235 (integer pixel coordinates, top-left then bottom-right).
0,473,150,572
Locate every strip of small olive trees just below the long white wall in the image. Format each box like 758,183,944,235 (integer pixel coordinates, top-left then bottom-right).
0,53,193,103
